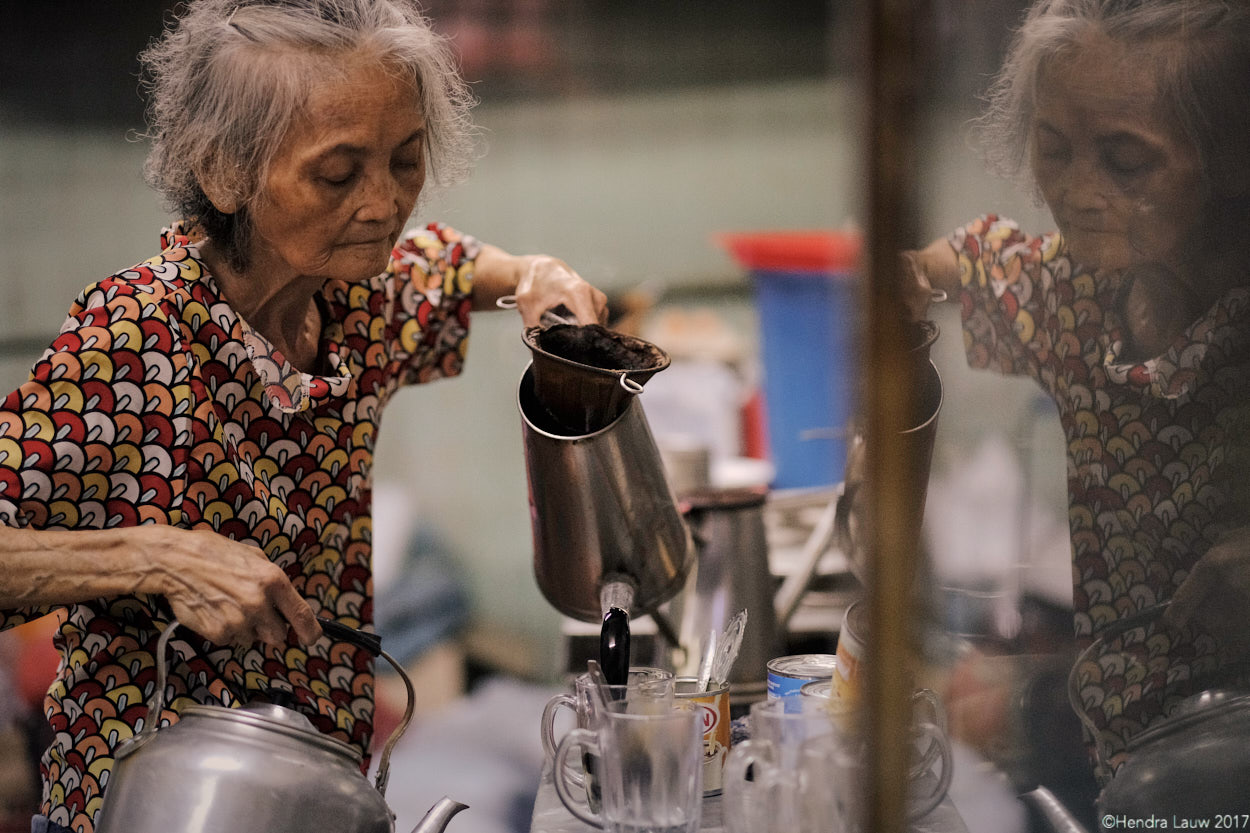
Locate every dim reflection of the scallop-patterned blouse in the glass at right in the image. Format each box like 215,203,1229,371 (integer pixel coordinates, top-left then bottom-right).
950,215,1250,779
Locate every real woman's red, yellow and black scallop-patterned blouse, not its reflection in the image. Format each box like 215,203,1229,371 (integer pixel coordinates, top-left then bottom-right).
0,217,478,833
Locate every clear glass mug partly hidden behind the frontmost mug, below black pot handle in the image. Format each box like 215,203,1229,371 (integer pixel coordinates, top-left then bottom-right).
539,665,673,813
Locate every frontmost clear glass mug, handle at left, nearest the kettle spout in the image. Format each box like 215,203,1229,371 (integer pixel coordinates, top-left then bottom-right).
553,705,703,833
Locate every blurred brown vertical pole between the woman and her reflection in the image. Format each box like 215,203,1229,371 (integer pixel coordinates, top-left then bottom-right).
863,0,925,833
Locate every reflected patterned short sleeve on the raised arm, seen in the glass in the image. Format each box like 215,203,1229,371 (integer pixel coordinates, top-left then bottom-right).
949,215,1070,378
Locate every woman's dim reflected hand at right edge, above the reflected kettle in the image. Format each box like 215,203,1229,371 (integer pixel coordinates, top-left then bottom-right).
1164,527,1250,658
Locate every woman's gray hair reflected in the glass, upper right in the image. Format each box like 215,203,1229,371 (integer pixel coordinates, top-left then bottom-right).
976,0,1250,200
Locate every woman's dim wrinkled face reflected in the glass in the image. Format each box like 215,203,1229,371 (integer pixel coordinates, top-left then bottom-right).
1031,34,1205,273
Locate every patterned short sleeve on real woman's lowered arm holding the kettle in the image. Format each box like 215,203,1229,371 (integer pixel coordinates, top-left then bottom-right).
0,279,193,627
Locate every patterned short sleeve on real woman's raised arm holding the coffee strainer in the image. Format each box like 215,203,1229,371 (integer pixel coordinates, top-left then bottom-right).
388,223,481,384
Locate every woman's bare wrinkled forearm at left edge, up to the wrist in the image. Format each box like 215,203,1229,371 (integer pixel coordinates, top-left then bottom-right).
0,527,164,608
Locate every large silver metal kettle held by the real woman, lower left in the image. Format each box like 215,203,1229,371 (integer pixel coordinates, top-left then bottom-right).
95,619,465,833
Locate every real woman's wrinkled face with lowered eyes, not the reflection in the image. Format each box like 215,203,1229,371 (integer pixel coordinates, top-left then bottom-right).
243,60,425,281
